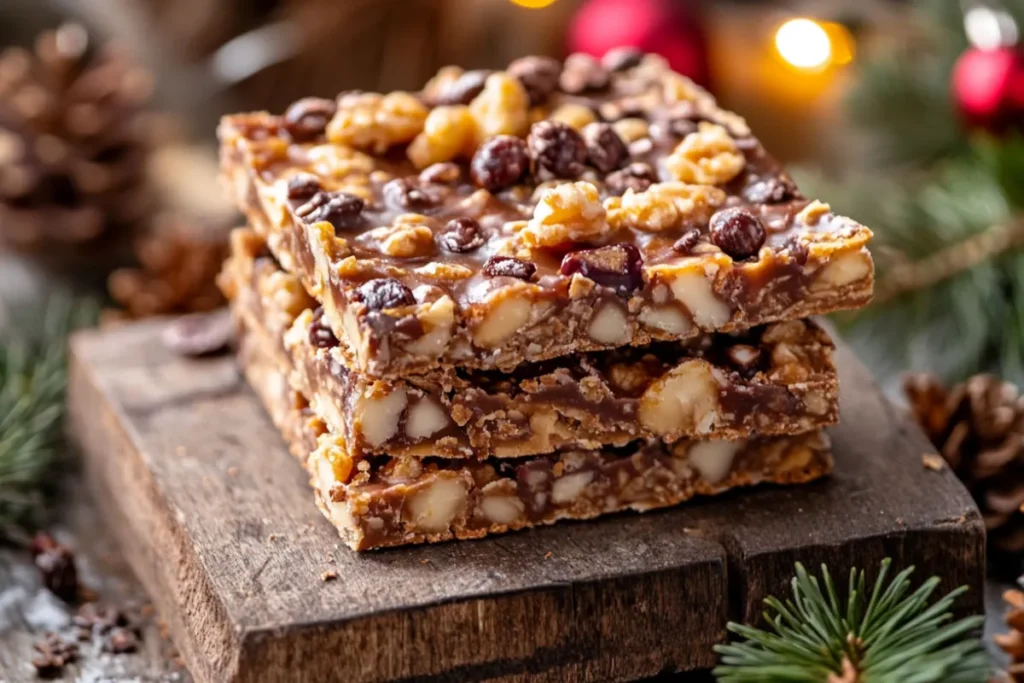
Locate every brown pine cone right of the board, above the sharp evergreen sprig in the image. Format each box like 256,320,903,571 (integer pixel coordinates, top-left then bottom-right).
903,375,1024,557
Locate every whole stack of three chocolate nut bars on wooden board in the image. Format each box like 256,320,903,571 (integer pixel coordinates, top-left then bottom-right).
219,49,873,550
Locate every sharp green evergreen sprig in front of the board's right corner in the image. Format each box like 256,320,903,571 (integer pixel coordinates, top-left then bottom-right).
714,559,990,683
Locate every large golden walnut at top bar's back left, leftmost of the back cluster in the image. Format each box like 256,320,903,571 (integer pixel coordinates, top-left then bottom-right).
327,92,427,155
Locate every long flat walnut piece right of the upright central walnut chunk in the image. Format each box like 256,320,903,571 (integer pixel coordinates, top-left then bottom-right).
604,182,726,232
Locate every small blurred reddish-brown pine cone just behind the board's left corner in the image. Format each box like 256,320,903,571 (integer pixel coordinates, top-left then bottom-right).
108,215,228,318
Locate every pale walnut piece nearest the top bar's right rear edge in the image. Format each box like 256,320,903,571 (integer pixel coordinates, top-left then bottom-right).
665,122,746,185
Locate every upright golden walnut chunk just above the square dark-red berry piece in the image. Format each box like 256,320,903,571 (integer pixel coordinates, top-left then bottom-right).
518,181,608,247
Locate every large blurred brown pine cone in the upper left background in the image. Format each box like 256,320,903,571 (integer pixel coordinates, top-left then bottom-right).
0,25,152,250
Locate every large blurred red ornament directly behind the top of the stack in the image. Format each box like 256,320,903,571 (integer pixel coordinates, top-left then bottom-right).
568,0,709,86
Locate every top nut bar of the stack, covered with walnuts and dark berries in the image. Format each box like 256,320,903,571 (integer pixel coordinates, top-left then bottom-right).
219,50,873,378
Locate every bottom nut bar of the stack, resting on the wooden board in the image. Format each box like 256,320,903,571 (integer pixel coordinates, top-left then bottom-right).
240,319,831,550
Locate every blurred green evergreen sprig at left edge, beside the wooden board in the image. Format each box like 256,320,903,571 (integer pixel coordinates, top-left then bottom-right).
0,298,93,537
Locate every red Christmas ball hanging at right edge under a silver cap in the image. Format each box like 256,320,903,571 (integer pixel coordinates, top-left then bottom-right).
951,46,1024,132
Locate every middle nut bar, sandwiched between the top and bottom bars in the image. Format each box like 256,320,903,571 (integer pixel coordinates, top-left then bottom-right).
221,228,839,458
